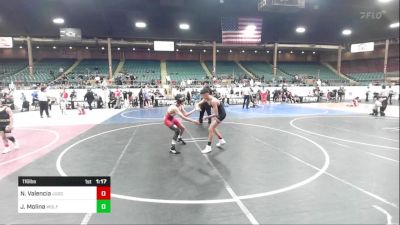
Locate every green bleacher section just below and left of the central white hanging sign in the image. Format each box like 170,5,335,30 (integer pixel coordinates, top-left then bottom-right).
123,60,161,82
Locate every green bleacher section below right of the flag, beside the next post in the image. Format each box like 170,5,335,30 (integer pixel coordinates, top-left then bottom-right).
240,61,292,81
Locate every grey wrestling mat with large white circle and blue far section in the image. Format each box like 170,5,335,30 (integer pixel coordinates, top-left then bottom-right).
0,104,399,224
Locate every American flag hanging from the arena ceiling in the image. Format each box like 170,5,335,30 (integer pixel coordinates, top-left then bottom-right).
221,17,262,44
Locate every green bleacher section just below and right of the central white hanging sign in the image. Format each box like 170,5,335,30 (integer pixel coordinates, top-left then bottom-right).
167,61,207,82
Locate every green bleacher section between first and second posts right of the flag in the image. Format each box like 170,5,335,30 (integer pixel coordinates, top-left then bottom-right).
278,63,344,81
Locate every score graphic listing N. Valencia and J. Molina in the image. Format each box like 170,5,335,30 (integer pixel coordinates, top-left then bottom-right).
18,177,111,213
